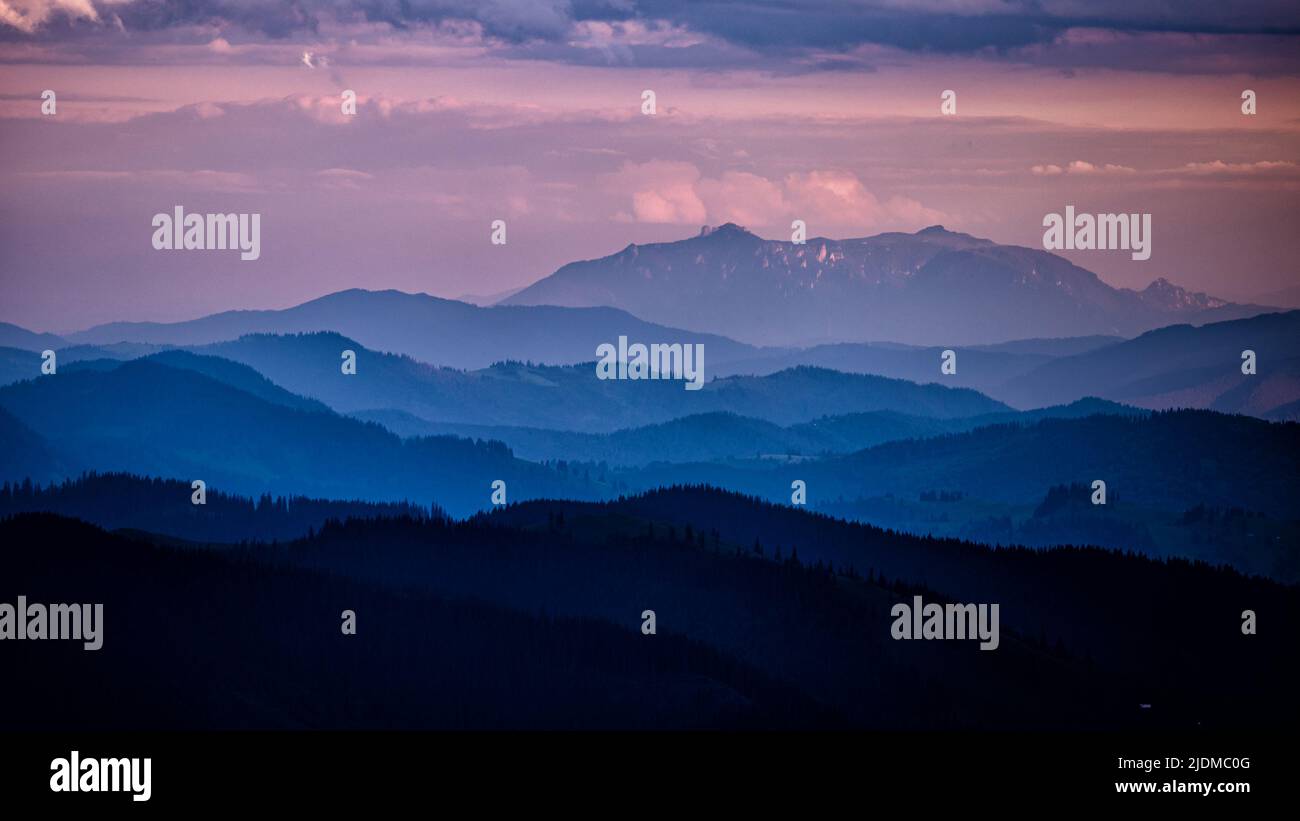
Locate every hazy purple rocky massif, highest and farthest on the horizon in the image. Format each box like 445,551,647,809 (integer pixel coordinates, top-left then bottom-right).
503,223,1266,347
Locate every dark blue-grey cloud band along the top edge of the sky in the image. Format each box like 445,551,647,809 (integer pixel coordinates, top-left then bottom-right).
0,0,1300,73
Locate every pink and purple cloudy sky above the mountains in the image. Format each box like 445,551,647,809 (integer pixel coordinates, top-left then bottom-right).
0,0,1300,333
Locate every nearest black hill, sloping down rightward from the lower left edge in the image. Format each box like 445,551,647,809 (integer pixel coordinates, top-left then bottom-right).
0,514,832,733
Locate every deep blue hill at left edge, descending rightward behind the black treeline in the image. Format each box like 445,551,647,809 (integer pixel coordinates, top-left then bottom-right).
0,359,614,514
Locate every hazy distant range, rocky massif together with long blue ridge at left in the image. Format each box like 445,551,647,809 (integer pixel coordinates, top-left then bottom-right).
0,223,1270,373
